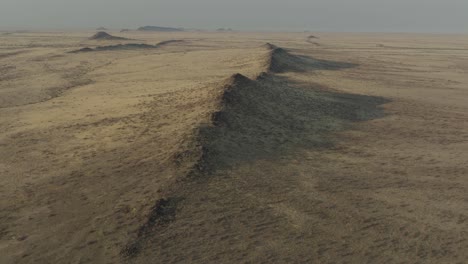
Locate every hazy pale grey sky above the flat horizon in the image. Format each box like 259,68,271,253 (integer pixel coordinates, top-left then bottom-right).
0,0,468,33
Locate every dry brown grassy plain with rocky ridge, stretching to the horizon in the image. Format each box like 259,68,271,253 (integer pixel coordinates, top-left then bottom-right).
0,31,468,264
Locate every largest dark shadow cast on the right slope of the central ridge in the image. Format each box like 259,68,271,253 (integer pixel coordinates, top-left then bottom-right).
197,74,389,173
